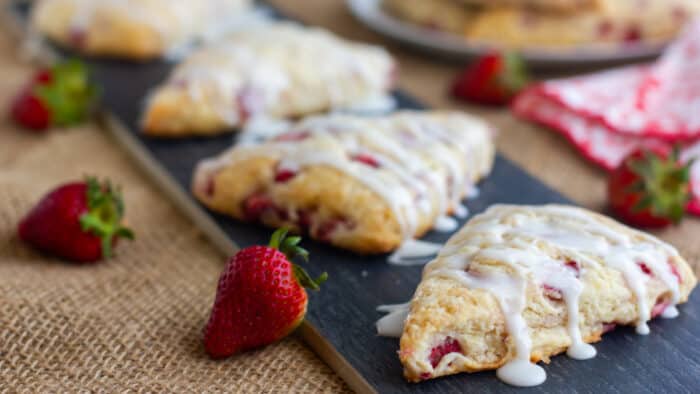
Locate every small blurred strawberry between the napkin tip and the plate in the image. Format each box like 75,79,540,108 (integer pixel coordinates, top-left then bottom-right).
452,52,528,105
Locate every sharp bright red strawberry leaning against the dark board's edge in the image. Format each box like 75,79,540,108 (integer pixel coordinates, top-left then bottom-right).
204,228,327,358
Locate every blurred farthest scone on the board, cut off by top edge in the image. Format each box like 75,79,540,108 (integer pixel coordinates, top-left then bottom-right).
31,0,251,60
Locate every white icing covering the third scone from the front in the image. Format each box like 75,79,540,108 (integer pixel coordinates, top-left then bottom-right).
162,22,395,123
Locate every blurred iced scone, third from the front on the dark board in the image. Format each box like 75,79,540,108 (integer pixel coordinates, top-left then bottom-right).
143,22,394,136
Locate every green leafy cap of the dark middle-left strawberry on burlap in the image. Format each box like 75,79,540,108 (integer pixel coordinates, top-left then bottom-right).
80,177,134,258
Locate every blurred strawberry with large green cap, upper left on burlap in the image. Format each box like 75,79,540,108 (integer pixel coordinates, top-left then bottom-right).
11,60,97,131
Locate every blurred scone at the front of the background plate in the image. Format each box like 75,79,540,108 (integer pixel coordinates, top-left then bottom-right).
384,0,700,49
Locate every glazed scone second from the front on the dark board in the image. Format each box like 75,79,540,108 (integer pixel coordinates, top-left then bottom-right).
192,111,494,253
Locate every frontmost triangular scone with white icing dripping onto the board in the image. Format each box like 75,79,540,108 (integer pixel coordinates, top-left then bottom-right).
400,205,696,385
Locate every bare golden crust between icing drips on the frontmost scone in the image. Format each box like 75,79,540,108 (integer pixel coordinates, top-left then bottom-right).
399,206,697,382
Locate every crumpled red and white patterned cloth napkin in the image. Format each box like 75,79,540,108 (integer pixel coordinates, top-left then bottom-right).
513,20,700,215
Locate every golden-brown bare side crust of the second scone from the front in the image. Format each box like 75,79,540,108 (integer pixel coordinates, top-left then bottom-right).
202,157,404,254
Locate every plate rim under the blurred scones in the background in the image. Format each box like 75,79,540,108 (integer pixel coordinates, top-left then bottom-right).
347,0,665,67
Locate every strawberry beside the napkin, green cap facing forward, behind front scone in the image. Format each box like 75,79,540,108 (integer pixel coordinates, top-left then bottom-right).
608,149,691,227
